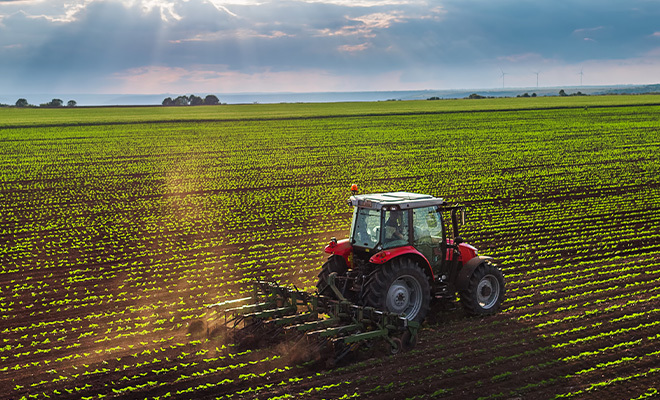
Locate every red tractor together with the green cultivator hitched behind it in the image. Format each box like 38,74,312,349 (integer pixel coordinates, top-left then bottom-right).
207,185,505,363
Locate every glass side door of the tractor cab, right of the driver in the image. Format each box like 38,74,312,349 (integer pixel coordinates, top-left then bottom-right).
412,206,446,271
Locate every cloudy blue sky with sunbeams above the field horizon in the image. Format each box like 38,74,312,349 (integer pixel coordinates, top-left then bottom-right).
0,0,660,95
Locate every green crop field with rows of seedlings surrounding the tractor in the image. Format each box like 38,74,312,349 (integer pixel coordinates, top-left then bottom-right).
0,96,660,399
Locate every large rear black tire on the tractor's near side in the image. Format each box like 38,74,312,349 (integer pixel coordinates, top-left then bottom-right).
362,258,431,322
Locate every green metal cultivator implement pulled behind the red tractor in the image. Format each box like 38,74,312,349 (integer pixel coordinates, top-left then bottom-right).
207,274,419,363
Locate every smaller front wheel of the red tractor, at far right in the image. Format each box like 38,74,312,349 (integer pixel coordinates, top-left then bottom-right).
460,262,505,316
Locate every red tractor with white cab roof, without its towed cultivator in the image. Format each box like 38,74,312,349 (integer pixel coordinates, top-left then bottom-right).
317,189,505,322
